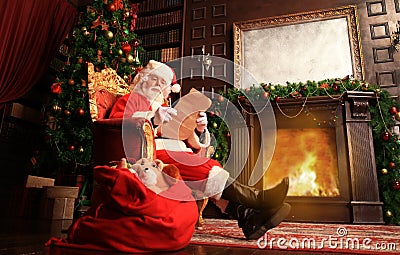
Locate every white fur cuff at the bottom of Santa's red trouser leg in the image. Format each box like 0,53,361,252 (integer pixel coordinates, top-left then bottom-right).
204,166,229,200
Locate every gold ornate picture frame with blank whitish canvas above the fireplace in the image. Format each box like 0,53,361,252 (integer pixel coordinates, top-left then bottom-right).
233,6,364,88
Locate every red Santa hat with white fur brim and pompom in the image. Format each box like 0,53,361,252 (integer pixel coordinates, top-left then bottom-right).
132,60,180,93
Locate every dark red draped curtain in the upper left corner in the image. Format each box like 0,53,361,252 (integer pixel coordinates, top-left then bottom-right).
0,0,78,105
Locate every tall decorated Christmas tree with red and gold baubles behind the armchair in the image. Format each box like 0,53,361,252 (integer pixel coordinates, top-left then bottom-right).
36,0,142,179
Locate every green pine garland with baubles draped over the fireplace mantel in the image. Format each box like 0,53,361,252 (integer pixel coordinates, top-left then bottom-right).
209,77,400,225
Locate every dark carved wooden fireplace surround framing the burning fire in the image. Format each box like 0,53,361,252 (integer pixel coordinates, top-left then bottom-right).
231,91,384,224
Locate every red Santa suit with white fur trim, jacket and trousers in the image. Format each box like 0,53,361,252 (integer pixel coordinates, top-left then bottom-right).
110,92,229,200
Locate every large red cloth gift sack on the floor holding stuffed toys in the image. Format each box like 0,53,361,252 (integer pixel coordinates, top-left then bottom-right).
46,166,199,253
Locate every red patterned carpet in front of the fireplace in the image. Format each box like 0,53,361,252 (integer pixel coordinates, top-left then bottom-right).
191,219,400,254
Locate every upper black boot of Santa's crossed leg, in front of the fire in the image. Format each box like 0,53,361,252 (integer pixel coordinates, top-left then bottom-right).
222,177,289,209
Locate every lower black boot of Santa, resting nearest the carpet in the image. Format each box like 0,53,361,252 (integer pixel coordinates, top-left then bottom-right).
225,202,291,240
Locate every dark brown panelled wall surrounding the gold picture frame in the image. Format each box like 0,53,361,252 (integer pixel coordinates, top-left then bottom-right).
183,0,400,96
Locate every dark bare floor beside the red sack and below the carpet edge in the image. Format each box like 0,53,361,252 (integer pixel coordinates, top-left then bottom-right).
0,218,360,255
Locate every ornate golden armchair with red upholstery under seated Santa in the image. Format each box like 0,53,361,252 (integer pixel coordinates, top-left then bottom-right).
88,63,208,228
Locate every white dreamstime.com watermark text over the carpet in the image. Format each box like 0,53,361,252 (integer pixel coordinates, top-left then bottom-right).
257,227,397,251
